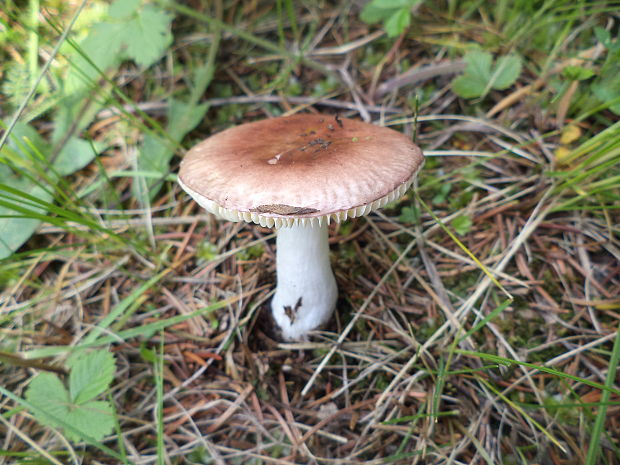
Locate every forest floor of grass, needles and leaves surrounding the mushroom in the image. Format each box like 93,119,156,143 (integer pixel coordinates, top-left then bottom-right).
0,0,620,465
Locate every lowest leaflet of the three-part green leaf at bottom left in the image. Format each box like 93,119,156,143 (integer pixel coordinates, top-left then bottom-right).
65,401,114,441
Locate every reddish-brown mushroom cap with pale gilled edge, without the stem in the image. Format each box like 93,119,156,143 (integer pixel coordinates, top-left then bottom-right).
178,114,424,227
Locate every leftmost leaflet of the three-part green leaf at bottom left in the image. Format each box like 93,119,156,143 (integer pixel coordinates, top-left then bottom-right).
26,373,70,426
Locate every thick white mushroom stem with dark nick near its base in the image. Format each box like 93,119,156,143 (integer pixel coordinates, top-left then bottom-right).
271,223,338,340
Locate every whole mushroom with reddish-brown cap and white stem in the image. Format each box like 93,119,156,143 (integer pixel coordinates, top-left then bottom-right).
178,114,424,340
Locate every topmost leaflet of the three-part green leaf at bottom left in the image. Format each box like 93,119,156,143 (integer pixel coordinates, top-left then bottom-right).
69,350,116,405
